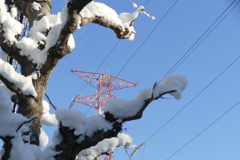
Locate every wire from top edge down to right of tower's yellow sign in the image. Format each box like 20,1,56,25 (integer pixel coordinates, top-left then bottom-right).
116,0,178,77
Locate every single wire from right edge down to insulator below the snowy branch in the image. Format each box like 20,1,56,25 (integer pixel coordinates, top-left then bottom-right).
147,56,240,141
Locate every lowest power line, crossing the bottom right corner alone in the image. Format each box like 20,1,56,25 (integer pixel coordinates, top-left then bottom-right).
166,101,240,160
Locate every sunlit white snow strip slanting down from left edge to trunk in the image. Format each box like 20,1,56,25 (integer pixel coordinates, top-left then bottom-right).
0,59,37,97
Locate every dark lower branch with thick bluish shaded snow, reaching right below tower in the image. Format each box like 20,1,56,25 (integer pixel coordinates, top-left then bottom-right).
40,75,188,160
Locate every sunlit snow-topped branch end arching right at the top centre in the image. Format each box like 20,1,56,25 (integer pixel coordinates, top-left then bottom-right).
80,1,154,40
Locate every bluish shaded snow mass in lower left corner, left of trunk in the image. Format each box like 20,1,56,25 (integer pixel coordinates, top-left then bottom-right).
0,89,41,160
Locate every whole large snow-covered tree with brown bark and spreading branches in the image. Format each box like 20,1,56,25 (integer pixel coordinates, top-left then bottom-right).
0,0,187,160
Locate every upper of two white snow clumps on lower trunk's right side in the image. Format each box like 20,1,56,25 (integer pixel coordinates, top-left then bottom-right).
42,100,58,126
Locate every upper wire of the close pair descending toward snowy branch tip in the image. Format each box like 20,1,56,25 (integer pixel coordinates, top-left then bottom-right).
164,0,236,77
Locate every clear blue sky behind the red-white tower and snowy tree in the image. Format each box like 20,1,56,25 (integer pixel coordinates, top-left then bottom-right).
46,0,240,160
